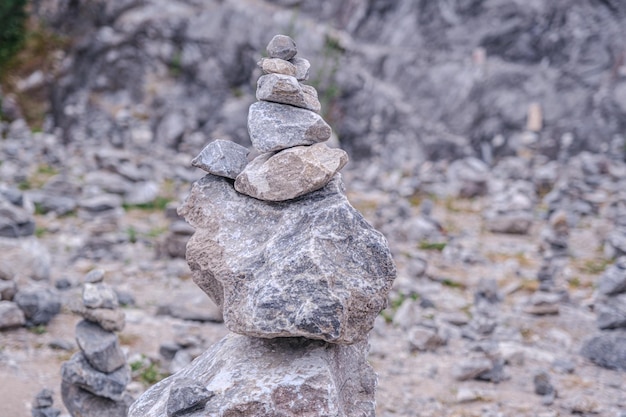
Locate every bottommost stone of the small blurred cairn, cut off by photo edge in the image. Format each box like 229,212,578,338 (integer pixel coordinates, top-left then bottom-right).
61,381,134,417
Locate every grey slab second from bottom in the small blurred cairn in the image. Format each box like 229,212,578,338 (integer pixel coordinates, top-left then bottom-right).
61,352,130,401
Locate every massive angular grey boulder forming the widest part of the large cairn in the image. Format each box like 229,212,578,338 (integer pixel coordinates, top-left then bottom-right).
179,175,396,343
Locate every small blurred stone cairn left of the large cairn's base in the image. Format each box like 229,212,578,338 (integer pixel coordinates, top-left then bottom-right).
61,270,133,417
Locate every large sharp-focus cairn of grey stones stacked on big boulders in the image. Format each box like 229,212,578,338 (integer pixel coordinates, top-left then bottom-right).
129,35,396,417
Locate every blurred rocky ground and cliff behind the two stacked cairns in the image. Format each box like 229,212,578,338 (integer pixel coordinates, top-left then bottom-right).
0,0,626,417
